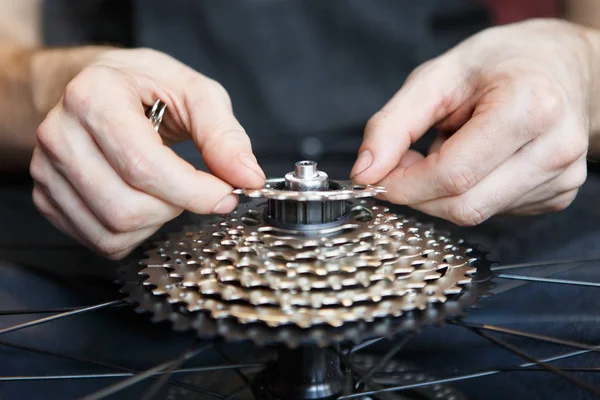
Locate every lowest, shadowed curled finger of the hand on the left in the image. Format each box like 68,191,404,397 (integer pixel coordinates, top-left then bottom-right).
34,148,160,259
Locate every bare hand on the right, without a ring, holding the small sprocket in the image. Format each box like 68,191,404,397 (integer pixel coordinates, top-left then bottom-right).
352,20,597,225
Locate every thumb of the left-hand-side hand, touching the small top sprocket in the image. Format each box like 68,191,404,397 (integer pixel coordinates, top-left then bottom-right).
186,80,265,188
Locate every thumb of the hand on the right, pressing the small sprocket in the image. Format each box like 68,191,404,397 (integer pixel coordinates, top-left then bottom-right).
351,54,469,184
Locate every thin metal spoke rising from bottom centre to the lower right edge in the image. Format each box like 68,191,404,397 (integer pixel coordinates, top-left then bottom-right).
338,345,600,400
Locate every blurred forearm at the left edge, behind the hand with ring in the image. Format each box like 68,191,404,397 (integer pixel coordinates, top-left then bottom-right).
0,43,106,174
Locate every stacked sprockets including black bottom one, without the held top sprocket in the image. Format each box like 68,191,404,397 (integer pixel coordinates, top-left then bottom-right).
119,199,492,347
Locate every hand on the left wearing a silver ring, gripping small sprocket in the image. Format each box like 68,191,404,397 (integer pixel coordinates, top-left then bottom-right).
30,49,264,259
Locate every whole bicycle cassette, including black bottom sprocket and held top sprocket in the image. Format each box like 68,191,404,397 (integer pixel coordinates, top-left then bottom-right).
123,161,490,346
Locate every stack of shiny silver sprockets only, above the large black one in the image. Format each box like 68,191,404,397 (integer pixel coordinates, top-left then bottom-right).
141,201,475,328
